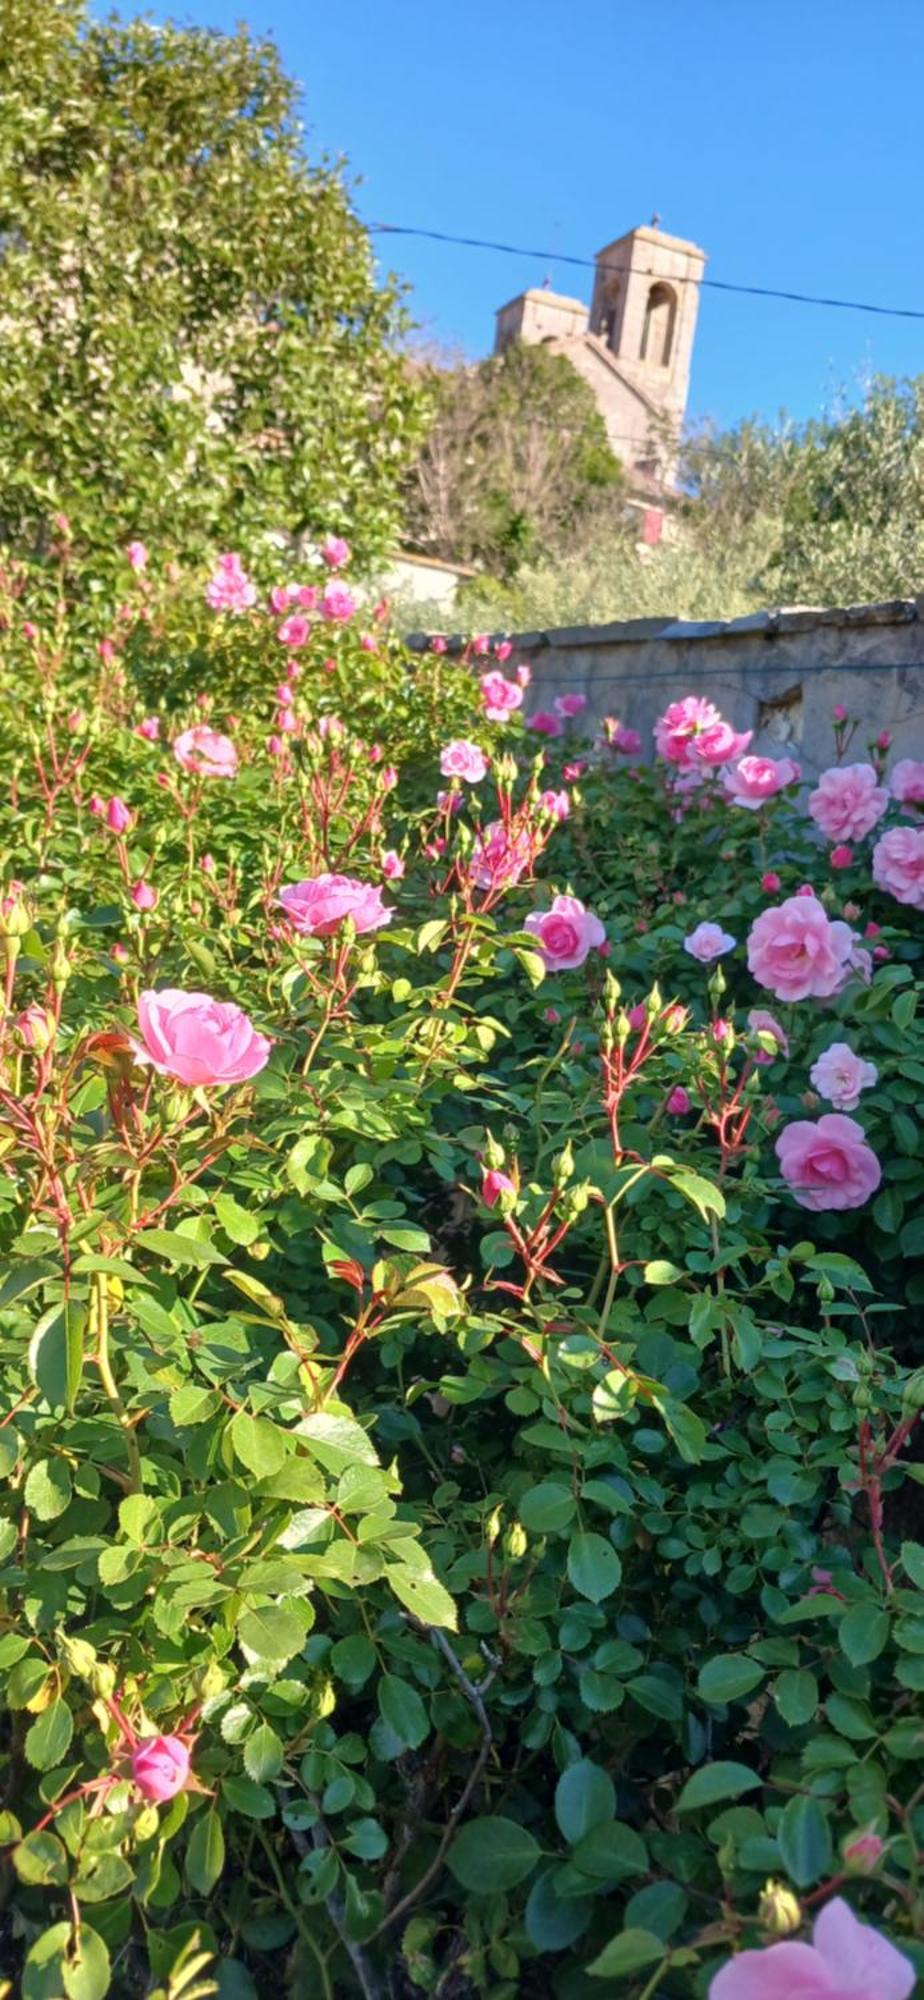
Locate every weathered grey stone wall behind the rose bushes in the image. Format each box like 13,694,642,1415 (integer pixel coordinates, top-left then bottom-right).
412,596,924,778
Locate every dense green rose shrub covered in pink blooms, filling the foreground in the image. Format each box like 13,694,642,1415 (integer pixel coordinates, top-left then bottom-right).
0,544,924,2000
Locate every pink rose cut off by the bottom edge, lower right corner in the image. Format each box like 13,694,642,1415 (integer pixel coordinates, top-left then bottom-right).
708,1896,916,2000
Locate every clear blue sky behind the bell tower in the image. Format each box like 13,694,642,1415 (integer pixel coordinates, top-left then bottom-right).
141,0,924,422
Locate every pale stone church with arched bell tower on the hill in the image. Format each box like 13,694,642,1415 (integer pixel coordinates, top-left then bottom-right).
494,224,706,540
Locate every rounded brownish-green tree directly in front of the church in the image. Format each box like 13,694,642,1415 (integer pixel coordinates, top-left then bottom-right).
408,344,622,574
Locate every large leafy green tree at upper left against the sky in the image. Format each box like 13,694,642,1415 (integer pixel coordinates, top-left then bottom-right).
0,0,420,572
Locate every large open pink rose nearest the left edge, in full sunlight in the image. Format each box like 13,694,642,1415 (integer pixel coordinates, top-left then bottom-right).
132,986,272,1088
